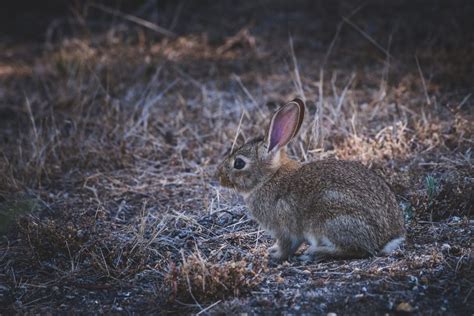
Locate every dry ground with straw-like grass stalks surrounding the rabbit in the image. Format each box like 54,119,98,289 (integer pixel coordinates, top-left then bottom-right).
0,0,474,315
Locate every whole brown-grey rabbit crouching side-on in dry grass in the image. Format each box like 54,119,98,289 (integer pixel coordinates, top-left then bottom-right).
217,99,405,261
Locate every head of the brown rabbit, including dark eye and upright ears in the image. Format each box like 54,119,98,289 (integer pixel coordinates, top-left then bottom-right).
217,99,305,195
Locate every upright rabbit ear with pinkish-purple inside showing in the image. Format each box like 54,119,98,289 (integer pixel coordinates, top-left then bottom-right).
266,99,304,152
